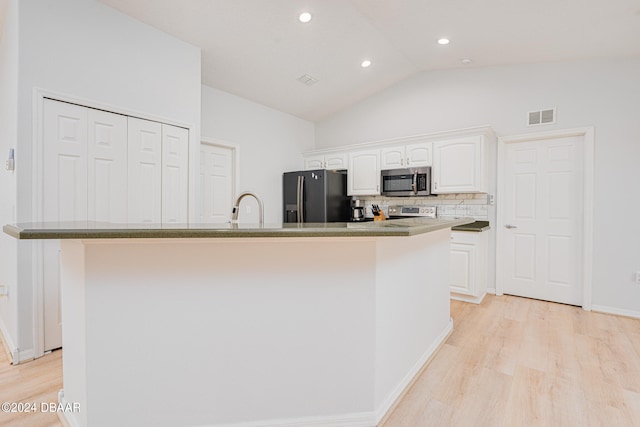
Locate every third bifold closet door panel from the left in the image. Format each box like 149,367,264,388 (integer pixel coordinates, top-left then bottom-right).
127,117,162,224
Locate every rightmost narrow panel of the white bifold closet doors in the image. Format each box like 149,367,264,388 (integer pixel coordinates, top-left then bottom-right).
162,124,189,223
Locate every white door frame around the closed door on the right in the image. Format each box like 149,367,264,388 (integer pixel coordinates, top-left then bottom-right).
496,126,595,311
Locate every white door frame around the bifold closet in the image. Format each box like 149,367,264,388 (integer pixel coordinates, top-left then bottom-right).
31,87,200,361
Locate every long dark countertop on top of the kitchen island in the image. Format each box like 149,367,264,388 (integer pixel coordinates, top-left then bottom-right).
3,218,473,239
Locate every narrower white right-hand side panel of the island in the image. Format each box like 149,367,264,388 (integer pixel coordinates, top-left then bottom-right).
375,229,452,421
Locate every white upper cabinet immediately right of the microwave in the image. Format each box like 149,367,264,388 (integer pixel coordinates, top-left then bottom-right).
431,135,489,194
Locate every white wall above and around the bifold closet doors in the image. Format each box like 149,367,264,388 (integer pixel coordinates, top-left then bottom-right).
0,0,200,362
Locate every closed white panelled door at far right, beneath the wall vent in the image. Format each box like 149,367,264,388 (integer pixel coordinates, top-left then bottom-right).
499,136,584,305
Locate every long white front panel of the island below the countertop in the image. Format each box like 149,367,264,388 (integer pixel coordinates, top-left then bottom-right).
74,238,376,427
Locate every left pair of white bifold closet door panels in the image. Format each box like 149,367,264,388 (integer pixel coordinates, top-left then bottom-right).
42,99,127,351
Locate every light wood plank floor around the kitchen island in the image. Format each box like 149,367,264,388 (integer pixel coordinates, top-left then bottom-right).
0,295,640,427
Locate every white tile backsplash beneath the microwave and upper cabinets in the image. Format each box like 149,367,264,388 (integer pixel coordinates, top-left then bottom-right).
352,194,490,220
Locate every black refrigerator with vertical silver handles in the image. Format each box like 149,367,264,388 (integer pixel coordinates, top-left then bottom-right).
282,169,351,222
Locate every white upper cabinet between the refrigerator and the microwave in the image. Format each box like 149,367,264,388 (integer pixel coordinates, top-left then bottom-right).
347,150,380,196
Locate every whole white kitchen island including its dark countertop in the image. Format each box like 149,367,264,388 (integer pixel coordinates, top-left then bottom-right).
4,218,473,426
